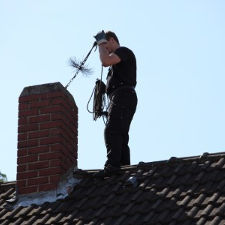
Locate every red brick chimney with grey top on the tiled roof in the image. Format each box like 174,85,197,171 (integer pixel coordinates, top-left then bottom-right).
17,83,78,195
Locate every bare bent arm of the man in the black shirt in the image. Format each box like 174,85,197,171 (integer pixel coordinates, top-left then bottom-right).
99,44,121,67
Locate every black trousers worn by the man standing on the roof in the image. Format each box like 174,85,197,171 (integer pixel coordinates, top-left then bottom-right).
105,87,137,167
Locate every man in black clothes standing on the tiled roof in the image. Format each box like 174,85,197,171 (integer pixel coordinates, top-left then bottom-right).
95,31,137,176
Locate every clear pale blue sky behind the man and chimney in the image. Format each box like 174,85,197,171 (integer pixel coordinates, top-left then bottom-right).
0,0,225,180
